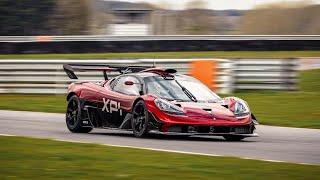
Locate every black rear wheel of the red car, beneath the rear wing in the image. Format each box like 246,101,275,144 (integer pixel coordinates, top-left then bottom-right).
66,95,92,133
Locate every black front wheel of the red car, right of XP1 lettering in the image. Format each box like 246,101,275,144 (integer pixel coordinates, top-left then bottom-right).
131,100,149,137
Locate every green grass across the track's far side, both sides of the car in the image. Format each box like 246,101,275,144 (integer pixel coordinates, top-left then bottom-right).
0,70,320,129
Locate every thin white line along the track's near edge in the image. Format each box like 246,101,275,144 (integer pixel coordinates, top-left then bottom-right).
0,134,317,166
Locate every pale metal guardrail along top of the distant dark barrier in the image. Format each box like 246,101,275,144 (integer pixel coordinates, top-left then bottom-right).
0,35,320,42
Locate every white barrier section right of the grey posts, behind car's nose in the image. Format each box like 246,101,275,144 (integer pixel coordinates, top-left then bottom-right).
233,59,299,90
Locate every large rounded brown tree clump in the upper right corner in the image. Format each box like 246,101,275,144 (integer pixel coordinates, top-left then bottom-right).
239,2,320,34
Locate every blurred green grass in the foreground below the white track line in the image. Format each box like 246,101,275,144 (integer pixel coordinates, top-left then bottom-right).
0,137,320,179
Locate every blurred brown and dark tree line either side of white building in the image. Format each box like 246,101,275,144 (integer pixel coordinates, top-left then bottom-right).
0,0,320,36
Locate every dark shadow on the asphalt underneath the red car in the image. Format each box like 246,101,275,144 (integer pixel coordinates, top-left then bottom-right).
90,131,256,143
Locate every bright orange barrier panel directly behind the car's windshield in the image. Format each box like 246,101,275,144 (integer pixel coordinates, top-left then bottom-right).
190,60,217,91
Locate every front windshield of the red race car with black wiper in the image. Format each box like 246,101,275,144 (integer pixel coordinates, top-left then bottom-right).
144,76,220,102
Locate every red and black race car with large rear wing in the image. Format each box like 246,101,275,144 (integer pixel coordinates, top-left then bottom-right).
63,64,257,141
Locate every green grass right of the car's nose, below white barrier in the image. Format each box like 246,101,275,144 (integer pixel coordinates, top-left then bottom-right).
235,69,320,129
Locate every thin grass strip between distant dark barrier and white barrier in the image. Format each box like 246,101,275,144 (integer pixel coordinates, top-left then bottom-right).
0,51,320,59
